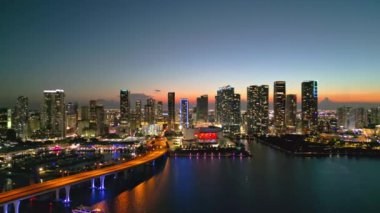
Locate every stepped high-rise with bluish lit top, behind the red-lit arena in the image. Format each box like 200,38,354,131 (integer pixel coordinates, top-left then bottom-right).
215,85,241,134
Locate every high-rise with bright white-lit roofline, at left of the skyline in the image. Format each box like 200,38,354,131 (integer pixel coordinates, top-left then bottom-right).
42,89,66,138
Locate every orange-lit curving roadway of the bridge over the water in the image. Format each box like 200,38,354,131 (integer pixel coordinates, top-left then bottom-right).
0,149,167,205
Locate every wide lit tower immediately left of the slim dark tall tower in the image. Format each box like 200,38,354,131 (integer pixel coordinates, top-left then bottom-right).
246,85,269,135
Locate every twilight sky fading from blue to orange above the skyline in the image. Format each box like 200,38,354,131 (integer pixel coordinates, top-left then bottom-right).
0,0,380,106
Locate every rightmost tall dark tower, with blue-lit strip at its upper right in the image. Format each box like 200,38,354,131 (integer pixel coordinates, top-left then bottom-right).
301,81,318,134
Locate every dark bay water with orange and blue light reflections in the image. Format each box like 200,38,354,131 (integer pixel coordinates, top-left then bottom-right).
21,142,380,213
